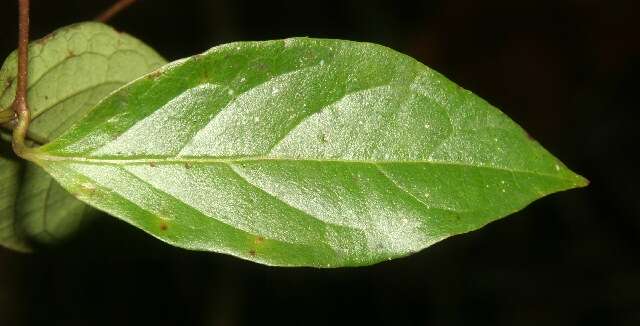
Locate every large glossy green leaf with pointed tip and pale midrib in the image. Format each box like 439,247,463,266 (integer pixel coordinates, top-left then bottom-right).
30,38,586,267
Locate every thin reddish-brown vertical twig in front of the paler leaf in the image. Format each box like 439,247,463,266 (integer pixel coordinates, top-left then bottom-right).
13,0,31,156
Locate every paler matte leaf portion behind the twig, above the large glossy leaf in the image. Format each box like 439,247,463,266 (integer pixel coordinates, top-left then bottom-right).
0,22,166,143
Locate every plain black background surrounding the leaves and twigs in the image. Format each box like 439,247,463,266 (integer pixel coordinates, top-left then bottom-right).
0,0,640,326
